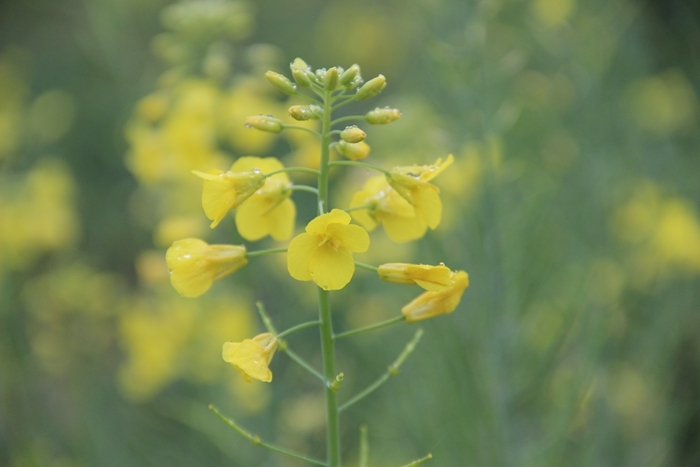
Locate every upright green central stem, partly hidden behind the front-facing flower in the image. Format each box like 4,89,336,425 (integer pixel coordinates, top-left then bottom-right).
318,91,340,467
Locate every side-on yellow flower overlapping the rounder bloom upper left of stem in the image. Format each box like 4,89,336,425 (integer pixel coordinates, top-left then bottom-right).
192,164,265,229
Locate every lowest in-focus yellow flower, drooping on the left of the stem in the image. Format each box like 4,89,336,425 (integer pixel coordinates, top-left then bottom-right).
221,332,277,383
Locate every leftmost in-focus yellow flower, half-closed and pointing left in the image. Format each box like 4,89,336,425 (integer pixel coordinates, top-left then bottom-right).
165,238,248,297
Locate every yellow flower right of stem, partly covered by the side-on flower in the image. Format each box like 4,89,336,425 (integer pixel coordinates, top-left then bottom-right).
350,175,428,242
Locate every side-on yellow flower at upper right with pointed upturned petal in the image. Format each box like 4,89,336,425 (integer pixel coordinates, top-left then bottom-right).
387,154,454,229
